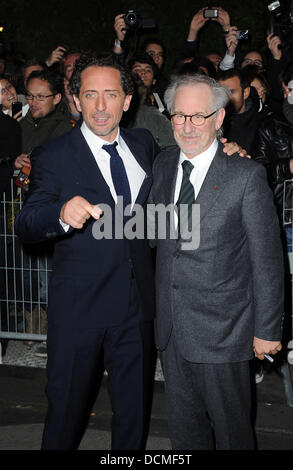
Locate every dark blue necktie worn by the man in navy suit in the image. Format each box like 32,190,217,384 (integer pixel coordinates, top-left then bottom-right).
103,142,131,210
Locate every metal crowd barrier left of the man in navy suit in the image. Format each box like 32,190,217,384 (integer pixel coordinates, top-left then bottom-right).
0,179,51,350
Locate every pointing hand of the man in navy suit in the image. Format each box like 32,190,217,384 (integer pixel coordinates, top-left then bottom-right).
60,196,103,229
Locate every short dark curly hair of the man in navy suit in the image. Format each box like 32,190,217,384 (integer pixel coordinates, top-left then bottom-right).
69,52,134,96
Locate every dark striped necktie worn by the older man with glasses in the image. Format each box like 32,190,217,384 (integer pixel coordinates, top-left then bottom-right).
176,160,195,238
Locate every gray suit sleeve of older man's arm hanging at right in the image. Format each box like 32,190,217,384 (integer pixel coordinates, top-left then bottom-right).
242,165,284,341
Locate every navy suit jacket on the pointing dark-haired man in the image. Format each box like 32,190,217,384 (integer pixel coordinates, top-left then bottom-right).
15,127,159,329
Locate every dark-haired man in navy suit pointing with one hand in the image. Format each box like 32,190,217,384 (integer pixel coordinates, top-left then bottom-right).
15,56,159,450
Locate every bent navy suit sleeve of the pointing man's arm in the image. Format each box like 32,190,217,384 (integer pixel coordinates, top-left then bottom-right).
15,147,71,243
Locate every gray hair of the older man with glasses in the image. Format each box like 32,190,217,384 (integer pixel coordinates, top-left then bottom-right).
164,73,230,138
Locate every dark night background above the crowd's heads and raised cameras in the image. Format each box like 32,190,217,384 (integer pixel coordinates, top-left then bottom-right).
0,0,267,68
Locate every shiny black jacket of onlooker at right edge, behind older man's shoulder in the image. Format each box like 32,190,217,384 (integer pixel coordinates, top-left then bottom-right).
252,117,293,221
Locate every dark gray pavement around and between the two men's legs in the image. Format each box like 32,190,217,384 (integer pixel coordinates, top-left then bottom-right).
0,340,293,457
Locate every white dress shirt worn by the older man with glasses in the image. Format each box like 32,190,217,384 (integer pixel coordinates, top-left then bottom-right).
174,139,218,226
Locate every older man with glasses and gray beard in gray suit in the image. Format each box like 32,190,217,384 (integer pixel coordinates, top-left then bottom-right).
149,75,283,450
